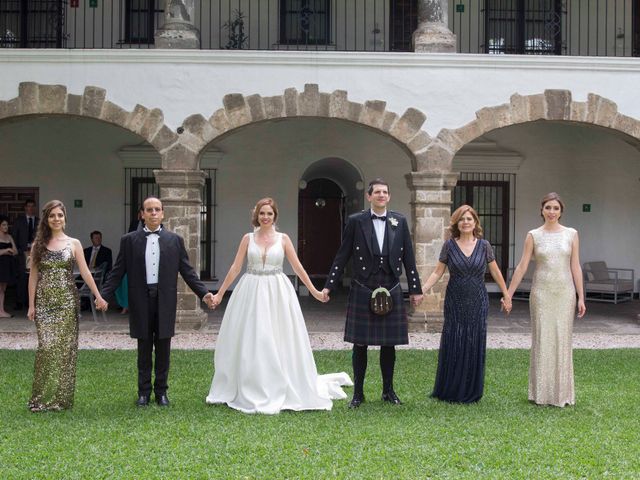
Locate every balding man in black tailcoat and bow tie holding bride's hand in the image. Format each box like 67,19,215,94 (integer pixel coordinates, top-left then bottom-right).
102,197,213,406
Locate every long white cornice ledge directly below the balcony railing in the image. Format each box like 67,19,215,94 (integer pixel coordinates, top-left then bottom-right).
0,49,640,72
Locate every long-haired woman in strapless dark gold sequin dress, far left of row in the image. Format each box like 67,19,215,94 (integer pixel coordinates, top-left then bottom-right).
27,200,107,412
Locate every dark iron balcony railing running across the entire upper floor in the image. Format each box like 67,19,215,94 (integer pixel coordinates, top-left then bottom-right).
0,0,640,56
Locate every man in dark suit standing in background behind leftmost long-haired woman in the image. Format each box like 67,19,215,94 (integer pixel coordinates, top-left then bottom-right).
13,198,40,310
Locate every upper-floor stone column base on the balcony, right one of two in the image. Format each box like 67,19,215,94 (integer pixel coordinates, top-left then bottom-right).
413,0,456,53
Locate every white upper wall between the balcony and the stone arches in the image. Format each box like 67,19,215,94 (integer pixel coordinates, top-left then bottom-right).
0,49,640,135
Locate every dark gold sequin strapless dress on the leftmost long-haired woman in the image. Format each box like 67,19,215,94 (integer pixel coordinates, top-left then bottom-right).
29,245,80,411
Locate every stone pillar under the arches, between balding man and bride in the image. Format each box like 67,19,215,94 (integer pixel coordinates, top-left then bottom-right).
153,170,207,329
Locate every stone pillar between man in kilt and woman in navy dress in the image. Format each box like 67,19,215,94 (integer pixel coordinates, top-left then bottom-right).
406,172,458,332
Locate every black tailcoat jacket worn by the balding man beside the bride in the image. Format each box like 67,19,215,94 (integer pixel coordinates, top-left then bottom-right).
102,228,208,339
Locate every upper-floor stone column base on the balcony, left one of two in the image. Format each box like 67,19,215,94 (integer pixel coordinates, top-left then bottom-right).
155,0,200,49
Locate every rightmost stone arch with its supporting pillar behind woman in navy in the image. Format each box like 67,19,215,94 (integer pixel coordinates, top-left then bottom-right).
412,90,640,331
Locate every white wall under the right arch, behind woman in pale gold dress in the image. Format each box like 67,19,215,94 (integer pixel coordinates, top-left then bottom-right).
487,123,640,284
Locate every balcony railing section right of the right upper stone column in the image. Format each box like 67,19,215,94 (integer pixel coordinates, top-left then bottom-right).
449,0,640,57
